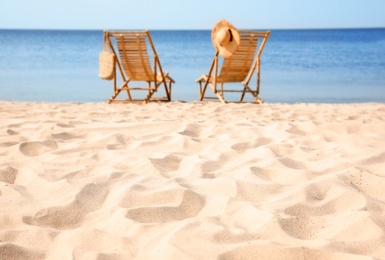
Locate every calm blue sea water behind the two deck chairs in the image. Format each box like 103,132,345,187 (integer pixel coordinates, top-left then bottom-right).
0,29,385,103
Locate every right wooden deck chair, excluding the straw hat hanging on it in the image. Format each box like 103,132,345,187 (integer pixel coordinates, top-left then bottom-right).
196,30,270,103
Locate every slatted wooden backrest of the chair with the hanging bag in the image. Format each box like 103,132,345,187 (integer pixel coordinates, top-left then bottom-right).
110,31,156,81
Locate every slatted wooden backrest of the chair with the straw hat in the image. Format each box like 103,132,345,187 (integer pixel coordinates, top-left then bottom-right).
217,30,268,83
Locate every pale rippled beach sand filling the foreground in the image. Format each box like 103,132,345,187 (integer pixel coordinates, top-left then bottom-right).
0,101,385,260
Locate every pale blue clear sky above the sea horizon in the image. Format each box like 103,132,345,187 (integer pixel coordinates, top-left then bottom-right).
0,0,385,30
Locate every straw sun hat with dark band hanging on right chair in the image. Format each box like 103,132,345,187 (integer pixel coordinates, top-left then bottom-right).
211,20,241,58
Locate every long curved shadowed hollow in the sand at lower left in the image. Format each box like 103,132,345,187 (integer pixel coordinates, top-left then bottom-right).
23,183,108,229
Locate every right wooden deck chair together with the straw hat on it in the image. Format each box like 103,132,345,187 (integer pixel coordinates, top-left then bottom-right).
196,20,270,103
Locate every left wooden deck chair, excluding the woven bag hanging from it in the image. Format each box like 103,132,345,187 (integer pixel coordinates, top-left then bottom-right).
105,30,175,103
